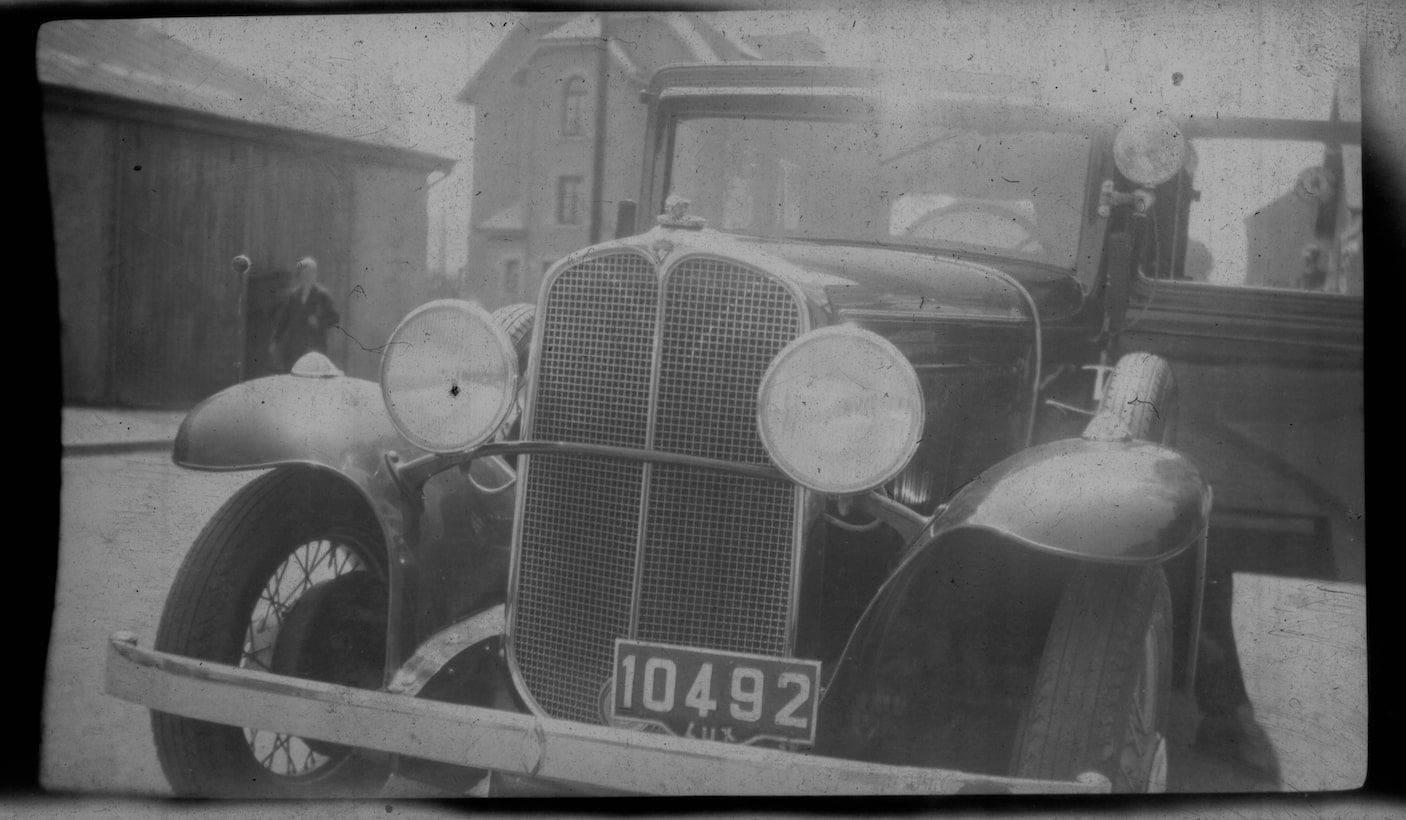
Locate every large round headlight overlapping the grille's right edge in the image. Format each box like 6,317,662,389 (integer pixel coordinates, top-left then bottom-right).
756,326,924,494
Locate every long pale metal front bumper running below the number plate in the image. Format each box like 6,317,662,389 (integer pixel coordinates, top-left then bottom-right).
105,633,1109,795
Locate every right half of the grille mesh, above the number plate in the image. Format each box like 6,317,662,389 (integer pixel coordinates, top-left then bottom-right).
638,259,800,654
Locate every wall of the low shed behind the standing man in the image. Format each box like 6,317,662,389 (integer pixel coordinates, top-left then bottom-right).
45,90,427,406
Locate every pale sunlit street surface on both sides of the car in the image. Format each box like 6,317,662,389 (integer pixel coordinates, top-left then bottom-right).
41,451,1367,796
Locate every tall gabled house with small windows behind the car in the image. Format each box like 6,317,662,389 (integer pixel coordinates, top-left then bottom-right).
457,13,824,308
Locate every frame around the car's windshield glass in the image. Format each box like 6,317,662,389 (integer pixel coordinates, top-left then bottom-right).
640,80,1114,293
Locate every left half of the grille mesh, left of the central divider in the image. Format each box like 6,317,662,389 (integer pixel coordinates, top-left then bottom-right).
513,253,658,720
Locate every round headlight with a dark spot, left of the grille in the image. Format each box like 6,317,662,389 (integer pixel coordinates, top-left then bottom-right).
381,300,517,453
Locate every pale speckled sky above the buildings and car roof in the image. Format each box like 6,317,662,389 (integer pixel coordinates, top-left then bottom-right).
153,0,1361,282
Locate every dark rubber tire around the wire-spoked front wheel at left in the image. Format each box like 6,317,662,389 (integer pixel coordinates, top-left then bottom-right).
152,470,389,797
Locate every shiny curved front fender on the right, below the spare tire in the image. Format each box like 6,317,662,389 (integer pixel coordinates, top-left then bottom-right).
817,439,1211,754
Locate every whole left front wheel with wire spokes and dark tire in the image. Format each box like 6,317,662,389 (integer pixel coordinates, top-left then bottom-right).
152,470,388,797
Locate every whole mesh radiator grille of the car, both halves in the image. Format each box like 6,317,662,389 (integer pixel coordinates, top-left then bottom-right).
512,253,801,723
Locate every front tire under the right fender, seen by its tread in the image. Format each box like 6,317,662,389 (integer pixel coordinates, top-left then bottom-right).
1011,564,1171,792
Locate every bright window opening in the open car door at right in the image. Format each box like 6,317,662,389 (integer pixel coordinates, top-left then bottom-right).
1180,138,1362,294
